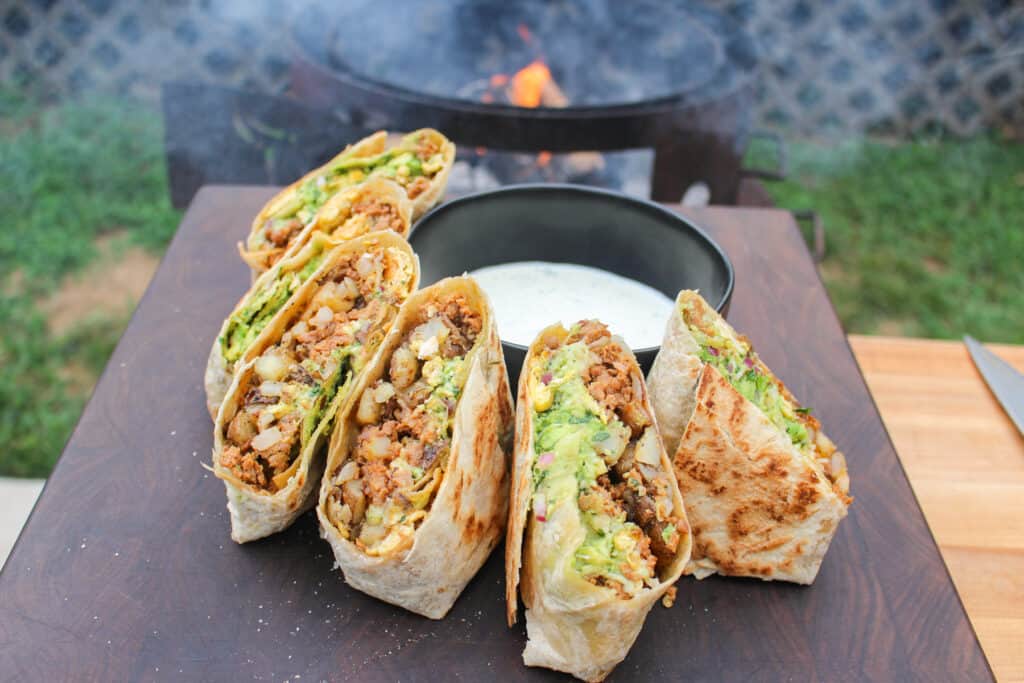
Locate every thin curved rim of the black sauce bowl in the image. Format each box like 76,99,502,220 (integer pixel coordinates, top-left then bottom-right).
408,182,736,354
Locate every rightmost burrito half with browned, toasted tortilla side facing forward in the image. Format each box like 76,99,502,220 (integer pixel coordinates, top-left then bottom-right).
648,290,851,584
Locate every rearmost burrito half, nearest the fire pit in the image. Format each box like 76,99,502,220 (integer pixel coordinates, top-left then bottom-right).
250,128,455,260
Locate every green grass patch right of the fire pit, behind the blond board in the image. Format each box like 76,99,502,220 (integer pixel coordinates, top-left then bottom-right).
768,136,1024,343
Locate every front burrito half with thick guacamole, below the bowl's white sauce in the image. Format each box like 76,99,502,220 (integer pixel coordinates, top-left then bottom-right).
505,321,691,681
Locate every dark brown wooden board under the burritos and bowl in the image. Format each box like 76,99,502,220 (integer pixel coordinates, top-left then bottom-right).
0,187,991,681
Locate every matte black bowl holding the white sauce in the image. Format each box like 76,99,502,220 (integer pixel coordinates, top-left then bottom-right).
409,184,733,393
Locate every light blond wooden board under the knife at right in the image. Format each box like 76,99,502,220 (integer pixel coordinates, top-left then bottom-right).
850,336,1024,683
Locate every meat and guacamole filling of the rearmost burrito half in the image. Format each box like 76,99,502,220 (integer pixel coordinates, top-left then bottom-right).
264,131,444,234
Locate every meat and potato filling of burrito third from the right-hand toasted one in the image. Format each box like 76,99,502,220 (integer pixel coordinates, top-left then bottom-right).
220,250,410,493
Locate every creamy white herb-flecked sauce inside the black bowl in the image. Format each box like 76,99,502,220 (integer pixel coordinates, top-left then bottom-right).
469,261,674,348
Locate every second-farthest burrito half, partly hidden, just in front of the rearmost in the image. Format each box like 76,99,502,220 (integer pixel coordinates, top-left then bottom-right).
239,176,413,275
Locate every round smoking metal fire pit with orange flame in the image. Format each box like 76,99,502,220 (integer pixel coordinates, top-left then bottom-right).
292,0,770,203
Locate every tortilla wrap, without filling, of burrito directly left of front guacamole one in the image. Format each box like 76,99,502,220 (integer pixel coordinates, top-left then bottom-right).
316,276,512,618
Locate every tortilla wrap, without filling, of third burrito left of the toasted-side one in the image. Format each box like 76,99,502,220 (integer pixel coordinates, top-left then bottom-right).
212,235,420,543
